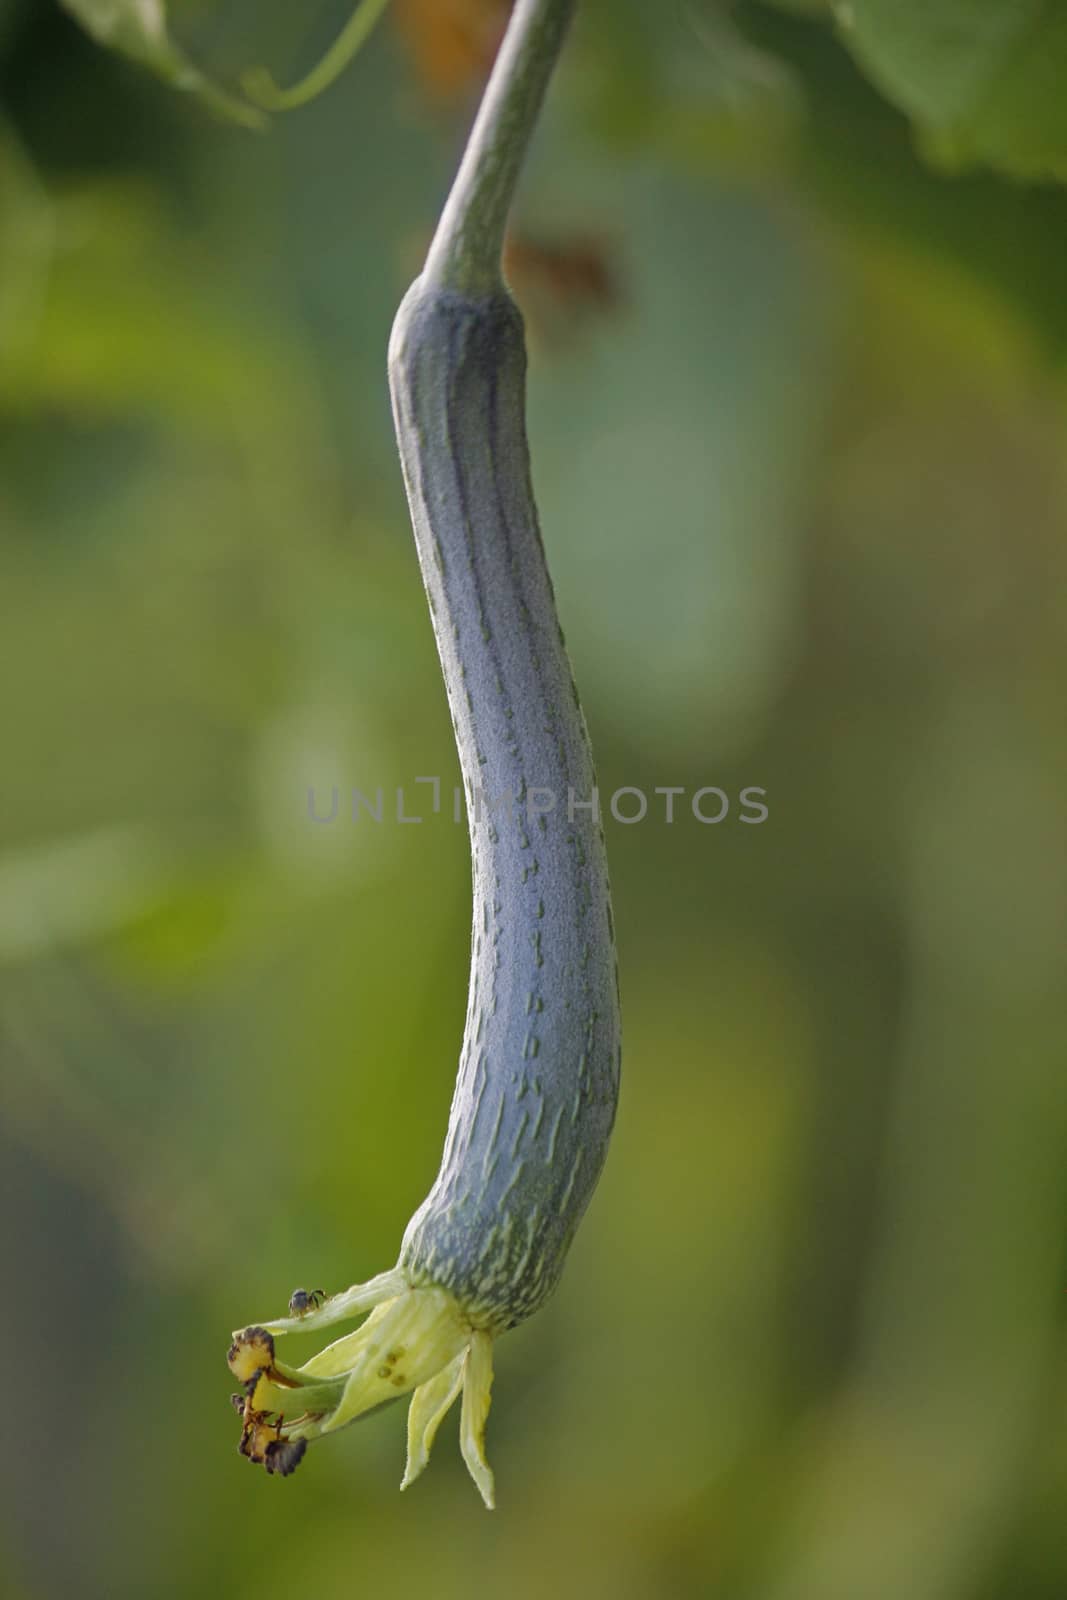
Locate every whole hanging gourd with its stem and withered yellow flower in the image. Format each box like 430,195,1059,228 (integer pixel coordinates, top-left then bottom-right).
230,0,619,1506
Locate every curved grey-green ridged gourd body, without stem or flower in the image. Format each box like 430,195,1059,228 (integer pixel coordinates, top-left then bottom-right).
389,280,621,1330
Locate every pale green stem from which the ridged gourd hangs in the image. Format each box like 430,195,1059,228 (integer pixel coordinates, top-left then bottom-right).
422,0,576,296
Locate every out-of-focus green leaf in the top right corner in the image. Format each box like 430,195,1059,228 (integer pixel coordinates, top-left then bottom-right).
835,0,1067,179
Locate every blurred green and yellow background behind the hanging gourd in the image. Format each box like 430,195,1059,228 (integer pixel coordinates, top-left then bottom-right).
0,0,1067,1600
